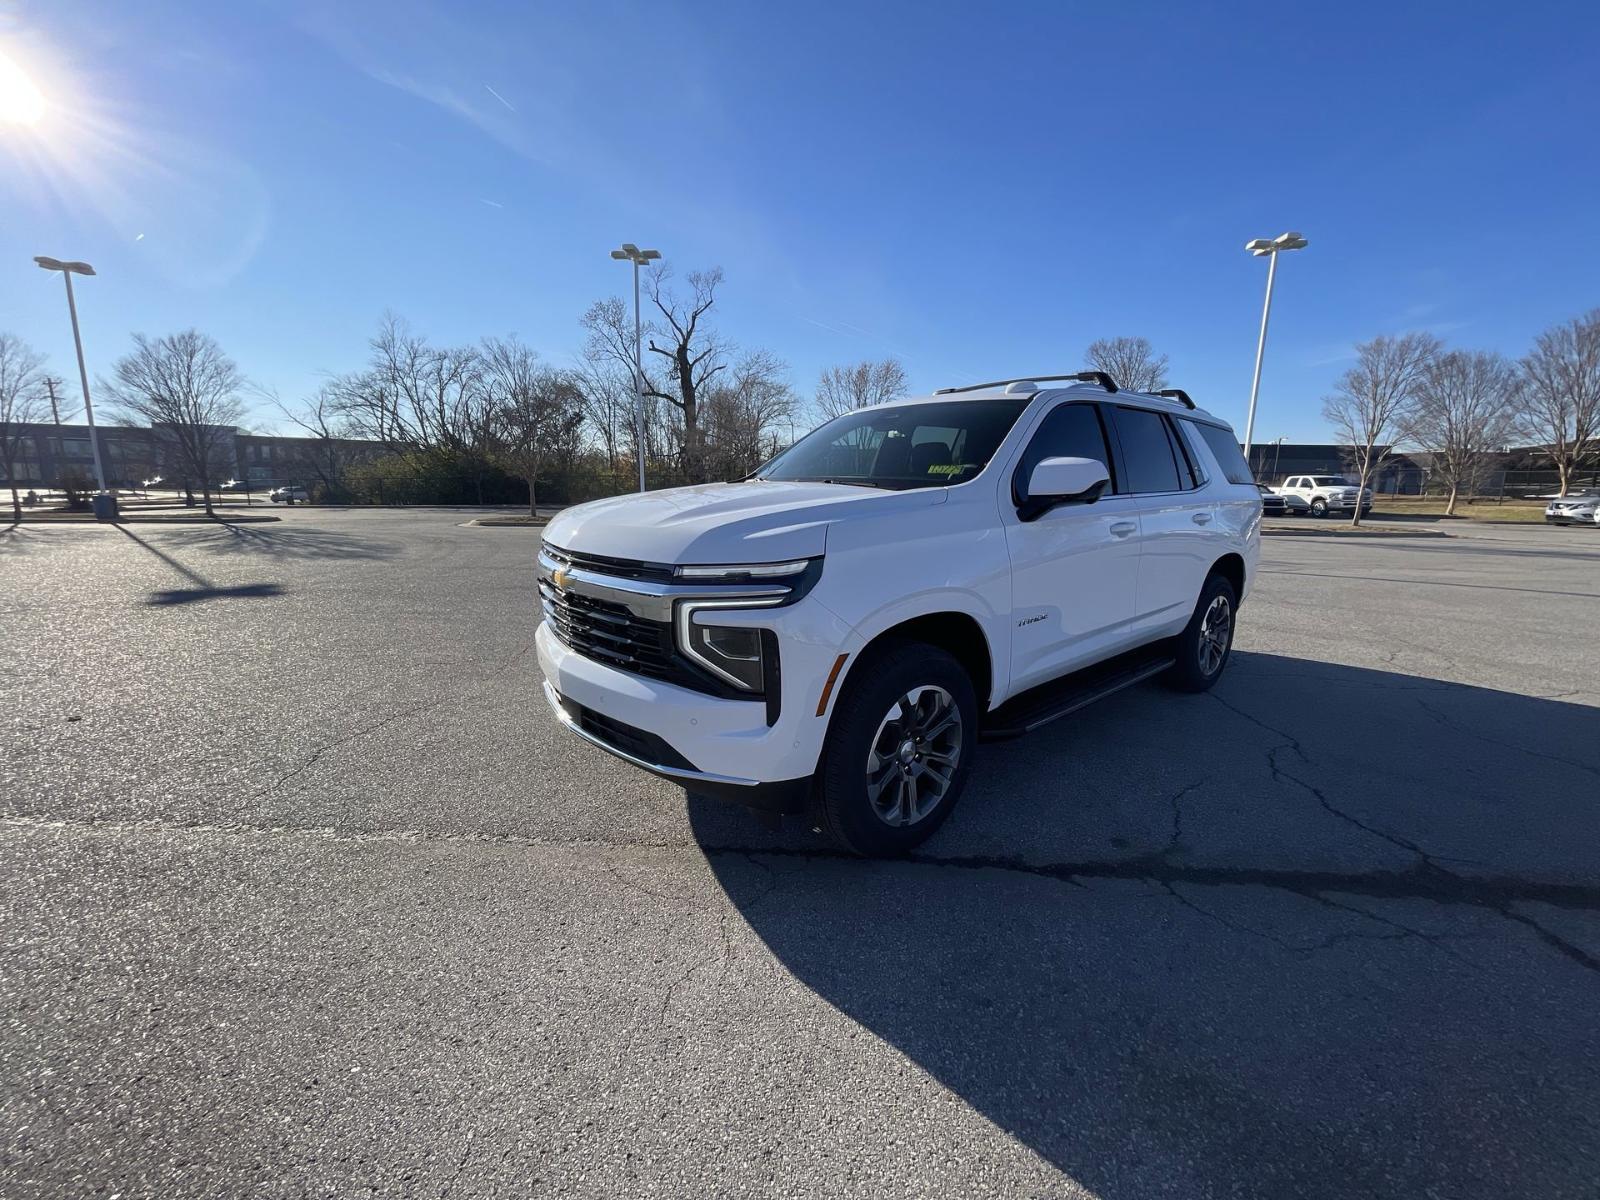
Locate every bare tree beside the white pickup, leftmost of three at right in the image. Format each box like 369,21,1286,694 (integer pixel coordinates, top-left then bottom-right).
1322,333,1440,525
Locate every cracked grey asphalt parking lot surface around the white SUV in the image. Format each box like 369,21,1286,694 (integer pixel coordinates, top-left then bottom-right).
0,509,1600,1200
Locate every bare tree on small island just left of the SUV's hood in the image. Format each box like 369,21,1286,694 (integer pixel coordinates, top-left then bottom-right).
482,338,584,517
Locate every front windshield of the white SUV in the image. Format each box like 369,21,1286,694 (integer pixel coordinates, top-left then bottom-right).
755,397,1032,490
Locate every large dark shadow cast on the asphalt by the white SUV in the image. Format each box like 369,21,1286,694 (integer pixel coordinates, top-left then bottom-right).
688,653,1600,1200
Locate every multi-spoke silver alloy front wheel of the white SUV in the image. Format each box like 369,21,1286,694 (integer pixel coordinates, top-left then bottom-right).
867,685,962,826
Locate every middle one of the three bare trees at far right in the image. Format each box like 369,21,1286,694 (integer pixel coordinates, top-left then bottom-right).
1410,350,1518,517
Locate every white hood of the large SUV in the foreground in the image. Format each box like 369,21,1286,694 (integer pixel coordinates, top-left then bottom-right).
544,480,944,563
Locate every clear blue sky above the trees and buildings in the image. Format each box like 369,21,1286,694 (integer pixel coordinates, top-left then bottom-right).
0,0,1600,440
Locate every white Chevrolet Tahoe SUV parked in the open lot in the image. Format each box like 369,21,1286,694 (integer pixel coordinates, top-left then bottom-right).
538,373,1261,854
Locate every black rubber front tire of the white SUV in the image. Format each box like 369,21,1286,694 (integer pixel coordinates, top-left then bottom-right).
816,642,978,858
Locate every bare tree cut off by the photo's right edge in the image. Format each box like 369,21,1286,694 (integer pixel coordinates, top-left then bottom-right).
1522,309,1600,496
